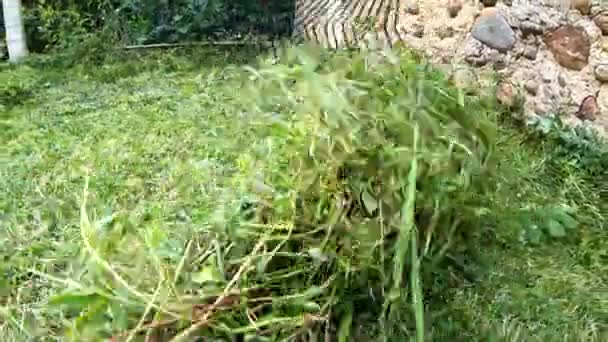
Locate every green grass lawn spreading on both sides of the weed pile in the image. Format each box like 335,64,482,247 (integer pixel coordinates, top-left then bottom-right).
0,47,608,341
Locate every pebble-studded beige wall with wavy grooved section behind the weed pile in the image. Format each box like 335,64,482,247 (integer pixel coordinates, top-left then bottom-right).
296,0,608,136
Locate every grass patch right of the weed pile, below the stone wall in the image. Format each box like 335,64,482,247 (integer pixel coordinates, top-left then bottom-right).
444,123,608,341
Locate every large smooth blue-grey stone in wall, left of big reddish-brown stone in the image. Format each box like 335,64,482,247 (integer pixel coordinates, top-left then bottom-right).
471,15,515,52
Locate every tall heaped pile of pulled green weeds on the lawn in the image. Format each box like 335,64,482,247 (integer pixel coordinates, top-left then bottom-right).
200,48,495,339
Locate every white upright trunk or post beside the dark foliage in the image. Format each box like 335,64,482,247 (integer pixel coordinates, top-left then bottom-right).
2,0,28,63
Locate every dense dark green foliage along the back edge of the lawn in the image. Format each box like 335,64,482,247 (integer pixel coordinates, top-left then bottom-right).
17,0,294,51
